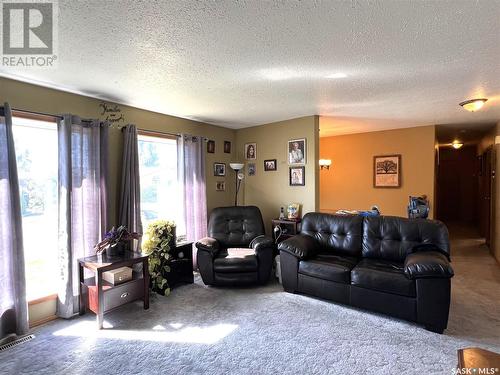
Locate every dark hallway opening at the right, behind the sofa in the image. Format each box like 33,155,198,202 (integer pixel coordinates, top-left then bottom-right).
436,124,496,254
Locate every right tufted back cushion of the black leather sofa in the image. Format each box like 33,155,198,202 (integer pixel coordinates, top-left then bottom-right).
363,216,450,262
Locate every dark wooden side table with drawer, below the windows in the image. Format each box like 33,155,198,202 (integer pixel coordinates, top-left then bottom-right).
78,252,149,329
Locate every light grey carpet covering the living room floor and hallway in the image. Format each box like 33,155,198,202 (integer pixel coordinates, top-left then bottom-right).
0,231,500,375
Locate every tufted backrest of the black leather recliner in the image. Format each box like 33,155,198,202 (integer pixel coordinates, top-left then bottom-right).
208,206,265,248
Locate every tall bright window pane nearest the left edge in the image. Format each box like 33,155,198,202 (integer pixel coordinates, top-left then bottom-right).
13,117,58,301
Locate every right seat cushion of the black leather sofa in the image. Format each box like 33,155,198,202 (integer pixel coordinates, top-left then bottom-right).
351,259,416,297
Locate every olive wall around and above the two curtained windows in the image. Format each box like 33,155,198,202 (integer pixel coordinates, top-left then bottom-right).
0,77,236,224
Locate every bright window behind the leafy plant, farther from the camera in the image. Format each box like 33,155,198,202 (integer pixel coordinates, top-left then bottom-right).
138,134,186,238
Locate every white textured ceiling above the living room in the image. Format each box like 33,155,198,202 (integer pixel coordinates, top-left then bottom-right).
0,0,500,135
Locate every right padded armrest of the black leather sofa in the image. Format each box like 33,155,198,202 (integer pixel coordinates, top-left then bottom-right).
404,251,454,279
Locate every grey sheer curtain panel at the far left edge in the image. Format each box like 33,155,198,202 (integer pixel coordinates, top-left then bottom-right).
0,104,29,342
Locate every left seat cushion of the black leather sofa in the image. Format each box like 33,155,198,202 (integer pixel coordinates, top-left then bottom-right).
299,254,357,284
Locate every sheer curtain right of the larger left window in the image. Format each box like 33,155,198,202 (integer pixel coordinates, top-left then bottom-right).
57,115,108,318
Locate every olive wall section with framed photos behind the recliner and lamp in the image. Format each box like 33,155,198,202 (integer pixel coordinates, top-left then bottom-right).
236,116,319,234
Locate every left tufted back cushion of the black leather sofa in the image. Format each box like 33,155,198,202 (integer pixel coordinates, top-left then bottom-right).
300,212,363,257
